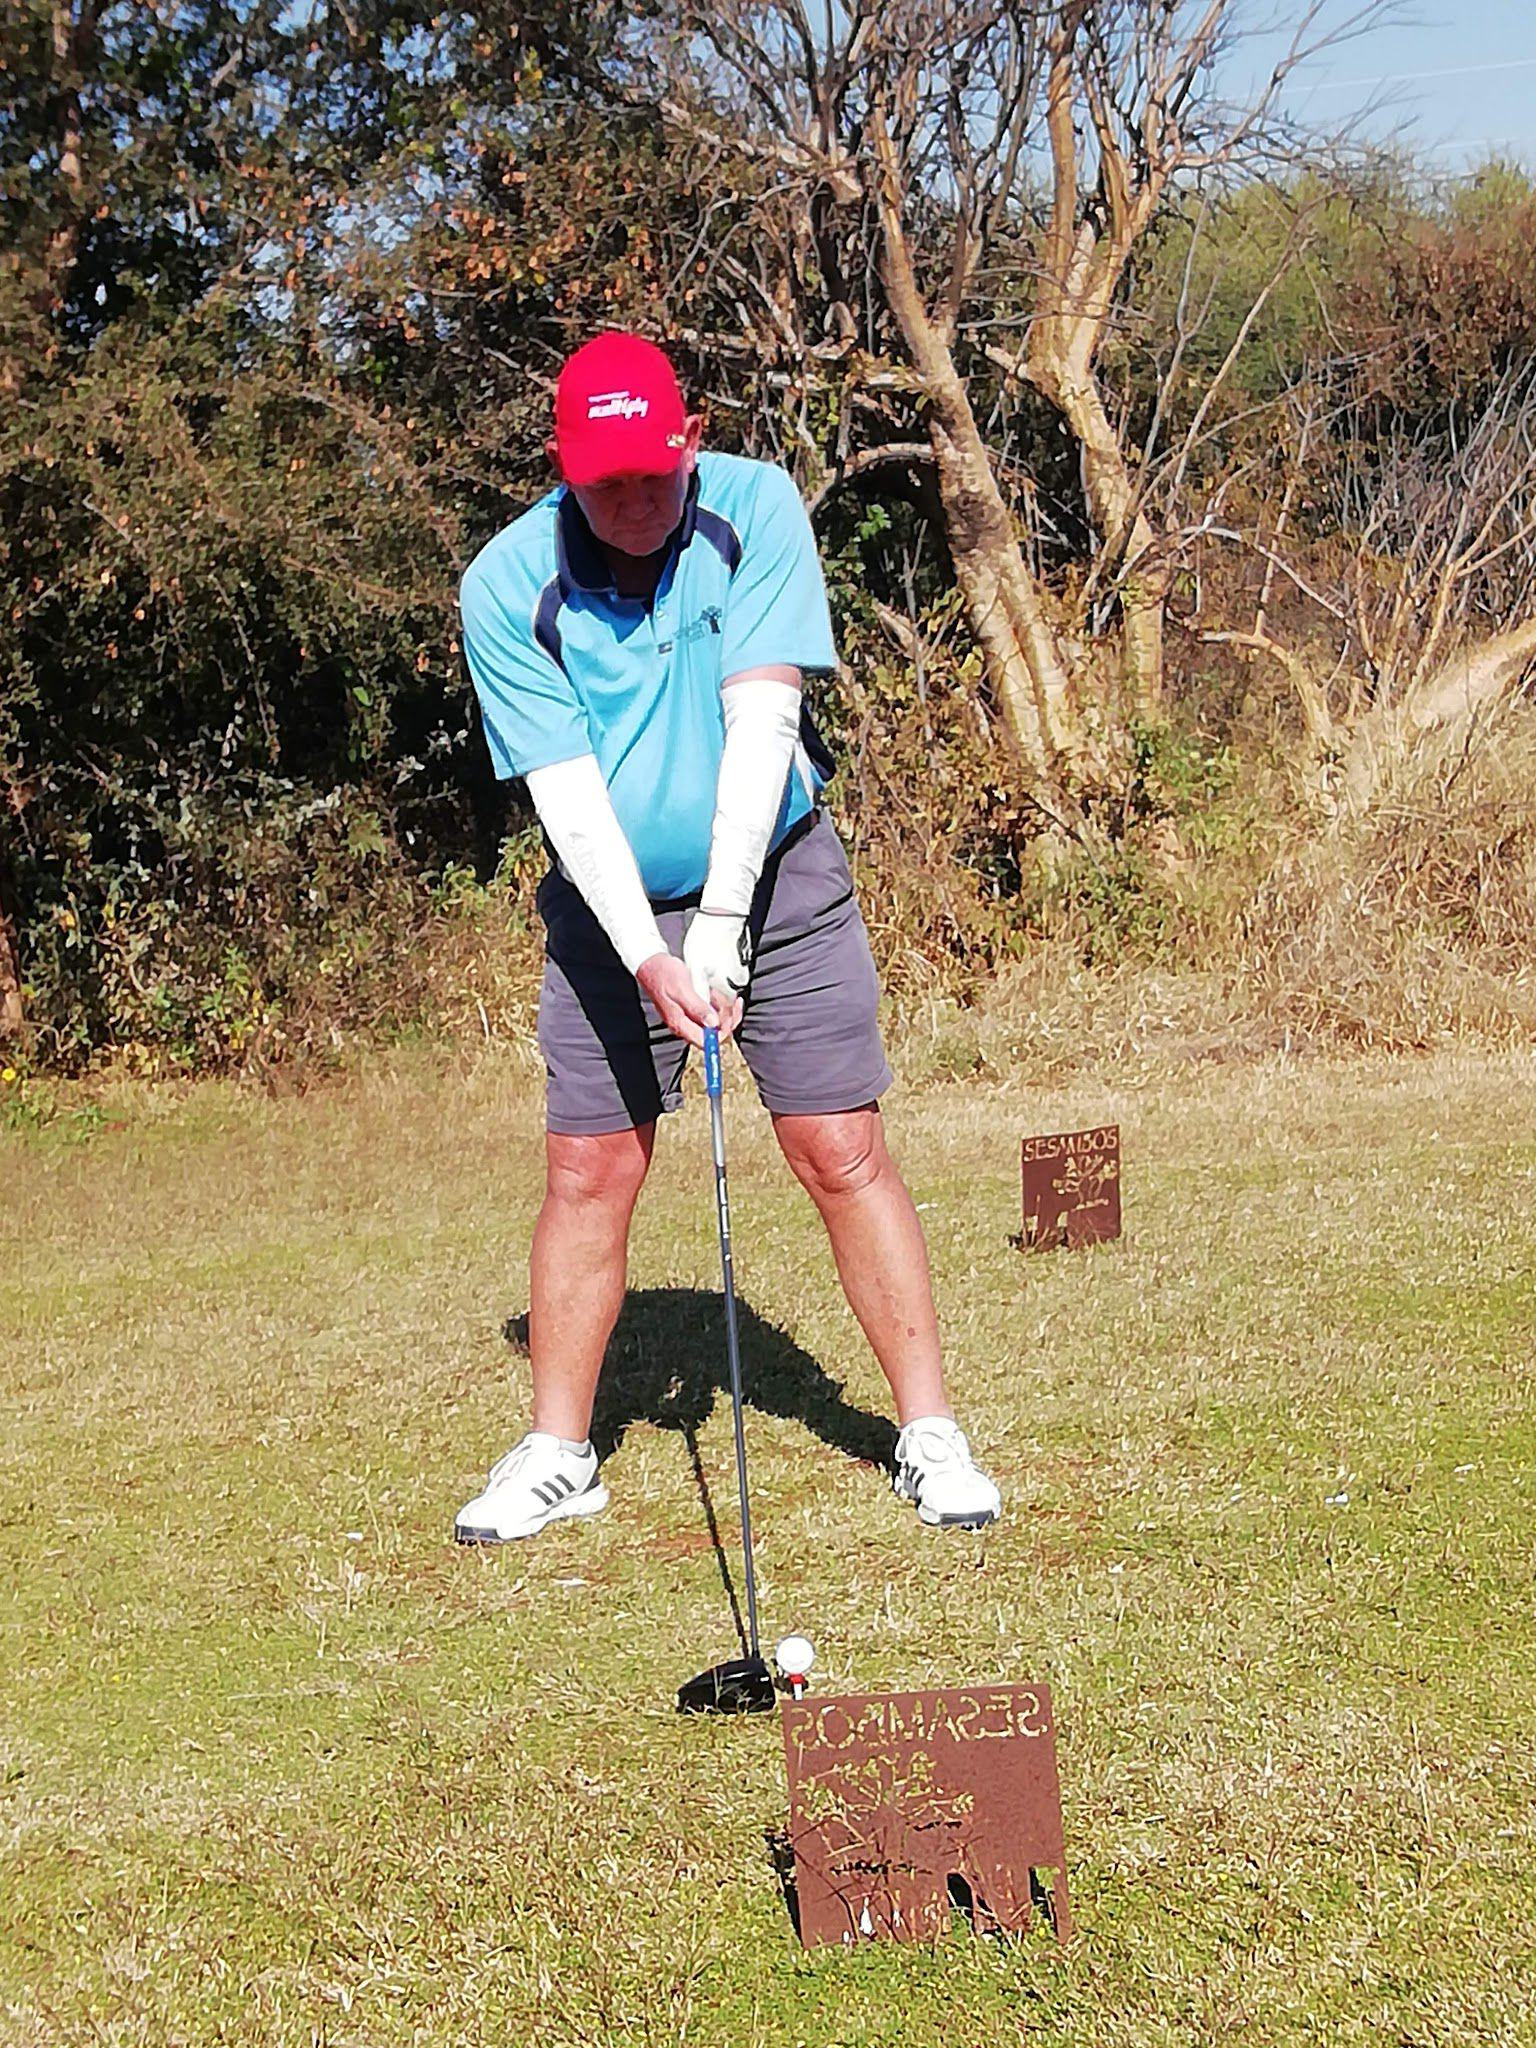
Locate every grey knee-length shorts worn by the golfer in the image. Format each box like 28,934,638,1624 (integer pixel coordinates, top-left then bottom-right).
539,817,891,1135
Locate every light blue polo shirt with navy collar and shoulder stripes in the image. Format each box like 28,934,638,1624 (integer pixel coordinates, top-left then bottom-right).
459,455,838,901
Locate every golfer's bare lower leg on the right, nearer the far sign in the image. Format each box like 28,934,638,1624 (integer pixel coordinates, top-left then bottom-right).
774,1102,952,1423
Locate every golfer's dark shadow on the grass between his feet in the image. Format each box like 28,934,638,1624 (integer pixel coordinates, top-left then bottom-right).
502,1286,897,1653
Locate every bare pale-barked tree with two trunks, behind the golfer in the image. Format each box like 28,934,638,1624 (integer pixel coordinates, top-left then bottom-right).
662,0,1372,829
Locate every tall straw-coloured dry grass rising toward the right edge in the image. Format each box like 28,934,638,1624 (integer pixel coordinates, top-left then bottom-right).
891,700,1536,1081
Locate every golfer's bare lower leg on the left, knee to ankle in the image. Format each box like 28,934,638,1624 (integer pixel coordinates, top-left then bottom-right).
528,1124,655,1444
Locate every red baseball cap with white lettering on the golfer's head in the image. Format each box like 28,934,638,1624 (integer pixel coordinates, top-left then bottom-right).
555,334,688,483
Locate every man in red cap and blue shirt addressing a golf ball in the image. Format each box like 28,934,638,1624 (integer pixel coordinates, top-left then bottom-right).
455,334,999,1542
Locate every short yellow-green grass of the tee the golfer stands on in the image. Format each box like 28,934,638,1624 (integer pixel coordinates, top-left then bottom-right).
0,1059,1536,2048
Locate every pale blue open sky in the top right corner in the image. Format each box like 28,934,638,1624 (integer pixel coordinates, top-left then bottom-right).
1227,0,1536,174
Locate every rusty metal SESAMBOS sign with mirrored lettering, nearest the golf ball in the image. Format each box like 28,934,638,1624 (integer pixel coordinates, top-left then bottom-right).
784,1686,1071,1948
